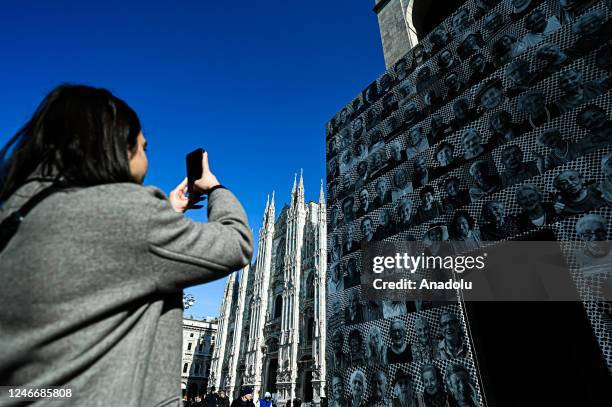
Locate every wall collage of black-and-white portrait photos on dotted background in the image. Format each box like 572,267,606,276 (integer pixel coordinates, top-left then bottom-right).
326,0,612,407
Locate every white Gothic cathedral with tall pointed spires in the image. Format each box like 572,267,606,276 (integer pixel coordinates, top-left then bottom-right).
209,175,327,405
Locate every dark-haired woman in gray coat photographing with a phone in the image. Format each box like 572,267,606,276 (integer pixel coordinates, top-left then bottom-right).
0,85,253,406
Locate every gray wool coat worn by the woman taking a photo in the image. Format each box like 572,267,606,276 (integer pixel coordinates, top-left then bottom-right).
0,182,253,406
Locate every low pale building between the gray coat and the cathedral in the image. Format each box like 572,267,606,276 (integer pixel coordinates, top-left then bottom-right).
181,318,218,398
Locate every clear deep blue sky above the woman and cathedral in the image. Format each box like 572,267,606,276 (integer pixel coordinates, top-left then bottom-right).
0,0,384,317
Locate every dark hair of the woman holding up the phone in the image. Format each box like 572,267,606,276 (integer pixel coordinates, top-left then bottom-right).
0,85,141,202
